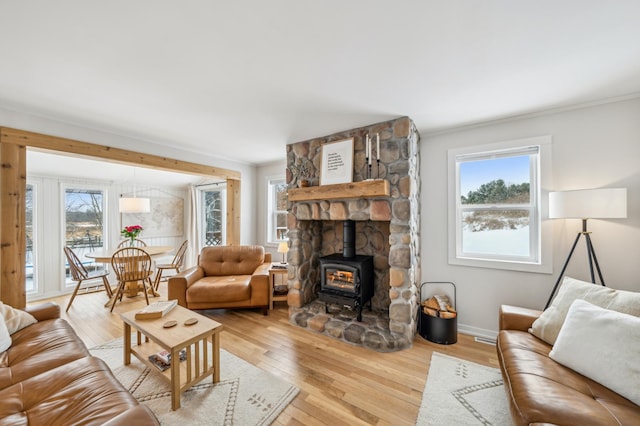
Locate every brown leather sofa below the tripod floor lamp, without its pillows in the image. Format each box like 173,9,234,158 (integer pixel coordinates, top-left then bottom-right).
497,305,640,426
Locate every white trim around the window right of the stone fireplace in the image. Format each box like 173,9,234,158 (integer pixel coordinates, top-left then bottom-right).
447,135,553,274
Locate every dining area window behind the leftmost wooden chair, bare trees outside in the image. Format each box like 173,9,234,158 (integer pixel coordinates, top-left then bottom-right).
63,186,106,287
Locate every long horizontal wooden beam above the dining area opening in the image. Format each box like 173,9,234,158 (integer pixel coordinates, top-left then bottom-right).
0,127,240,180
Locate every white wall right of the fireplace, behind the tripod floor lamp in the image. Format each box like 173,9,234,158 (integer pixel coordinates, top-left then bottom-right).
421,98,640,336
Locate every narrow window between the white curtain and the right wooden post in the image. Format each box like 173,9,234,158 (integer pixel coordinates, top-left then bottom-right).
199,184,227,247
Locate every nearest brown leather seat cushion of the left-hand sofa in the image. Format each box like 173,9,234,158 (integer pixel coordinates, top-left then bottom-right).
0,357,138,425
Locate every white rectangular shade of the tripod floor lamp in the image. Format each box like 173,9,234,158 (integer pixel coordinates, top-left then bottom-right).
549,188,627,219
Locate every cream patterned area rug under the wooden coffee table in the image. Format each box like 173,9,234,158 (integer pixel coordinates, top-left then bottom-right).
90,339,298,426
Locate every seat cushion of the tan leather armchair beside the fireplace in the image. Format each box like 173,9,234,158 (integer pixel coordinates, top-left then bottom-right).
187,275,251,303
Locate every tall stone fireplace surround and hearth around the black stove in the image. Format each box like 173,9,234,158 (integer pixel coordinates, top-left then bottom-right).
287,117,420,352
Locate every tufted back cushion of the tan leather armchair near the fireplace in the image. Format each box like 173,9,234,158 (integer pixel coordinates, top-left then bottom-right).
198,246,264,276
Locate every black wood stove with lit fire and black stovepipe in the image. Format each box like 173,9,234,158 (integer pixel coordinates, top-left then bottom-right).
318,220,374,321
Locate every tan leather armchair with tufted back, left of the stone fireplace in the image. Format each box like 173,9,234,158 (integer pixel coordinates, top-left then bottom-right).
168,246,271,315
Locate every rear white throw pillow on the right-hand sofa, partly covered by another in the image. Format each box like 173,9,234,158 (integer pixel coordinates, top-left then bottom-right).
529,277,640,345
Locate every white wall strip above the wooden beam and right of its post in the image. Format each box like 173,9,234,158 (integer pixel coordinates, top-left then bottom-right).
0,107,257,244
